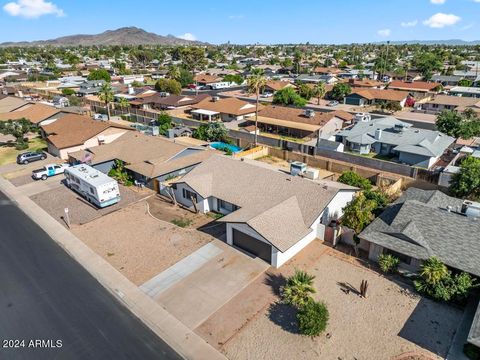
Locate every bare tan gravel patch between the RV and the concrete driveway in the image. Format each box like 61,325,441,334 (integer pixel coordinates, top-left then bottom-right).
72,201,212,285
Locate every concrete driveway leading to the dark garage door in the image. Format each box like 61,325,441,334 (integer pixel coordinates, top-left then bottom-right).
140,240,270,330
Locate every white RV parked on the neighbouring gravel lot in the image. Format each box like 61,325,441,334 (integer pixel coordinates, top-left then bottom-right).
65,164,120,208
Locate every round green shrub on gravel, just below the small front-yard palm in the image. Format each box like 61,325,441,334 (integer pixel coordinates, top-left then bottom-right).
297,300,329,336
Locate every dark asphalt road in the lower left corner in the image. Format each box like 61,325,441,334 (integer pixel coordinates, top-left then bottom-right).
0,192,181,360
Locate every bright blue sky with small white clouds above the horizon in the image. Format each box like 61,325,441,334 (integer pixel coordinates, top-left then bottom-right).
0,0,480,44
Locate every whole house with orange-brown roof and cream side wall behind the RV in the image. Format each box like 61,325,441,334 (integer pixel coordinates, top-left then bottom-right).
40,114,135,159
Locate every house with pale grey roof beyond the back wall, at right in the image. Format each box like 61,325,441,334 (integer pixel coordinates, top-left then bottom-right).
336,116,455,169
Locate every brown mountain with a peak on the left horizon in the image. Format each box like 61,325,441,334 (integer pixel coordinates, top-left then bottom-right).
0,26,202,46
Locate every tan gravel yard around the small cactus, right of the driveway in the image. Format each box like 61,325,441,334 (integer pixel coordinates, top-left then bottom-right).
223,250,462,360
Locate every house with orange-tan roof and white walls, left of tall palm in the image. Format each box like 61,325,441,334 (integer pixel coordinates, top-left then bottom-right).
190,96,263,122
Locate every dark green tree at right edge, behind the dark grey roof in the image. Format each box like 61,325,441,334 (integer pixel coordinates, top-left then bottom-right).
450,156,480,200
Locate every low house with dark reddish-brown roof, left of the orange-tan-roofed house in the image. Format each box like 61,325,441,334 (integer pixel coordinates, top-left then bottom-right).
130,93,210,110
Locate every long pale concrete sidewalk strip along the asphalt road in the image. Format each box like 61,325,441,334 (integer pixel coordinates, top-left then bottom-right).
0,176,226,360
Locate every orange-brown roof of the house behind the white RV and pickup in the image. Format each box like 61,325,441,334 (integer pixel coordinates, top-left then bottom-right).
41,114,134,149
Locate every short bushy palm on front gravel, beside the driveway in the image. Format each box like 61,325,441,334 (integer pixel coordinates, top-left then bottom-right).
281,269,315,308
